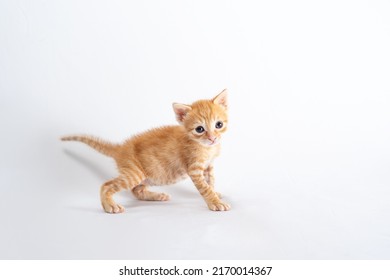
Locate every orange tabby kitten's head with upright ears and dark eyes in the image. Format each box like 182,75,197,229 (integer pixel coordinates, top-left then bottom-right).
173,89,228,147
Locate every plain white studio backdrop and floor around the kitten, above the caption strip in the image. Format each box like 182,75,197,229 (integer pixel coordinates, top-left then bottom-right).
0,0,390,259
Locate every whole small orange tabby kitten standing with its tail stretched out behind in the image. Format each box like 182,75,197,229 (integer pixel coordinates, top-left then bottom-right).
61,89,230,213
